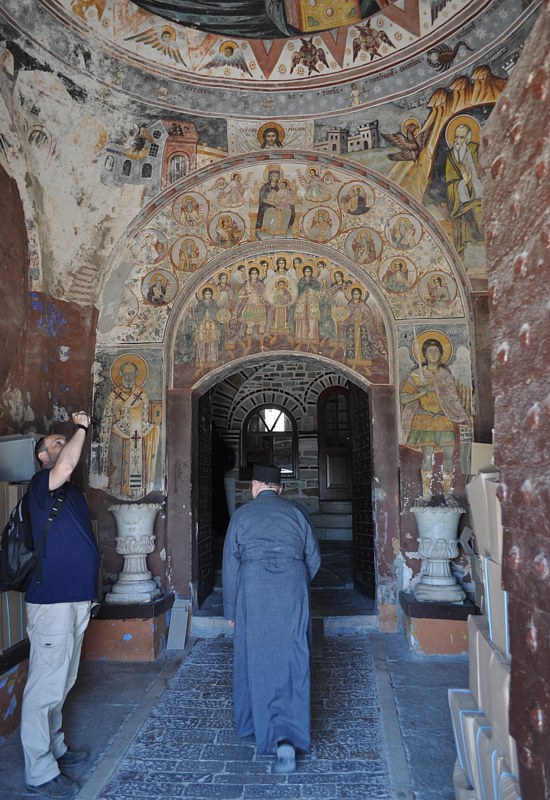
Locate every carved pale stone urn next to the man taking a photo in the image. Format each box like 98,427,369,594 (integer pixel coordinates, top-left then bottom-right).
105,503,161,604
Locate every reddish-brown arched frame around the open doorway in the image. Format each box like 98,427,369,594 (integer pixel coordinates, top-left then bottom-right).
167,353,399,628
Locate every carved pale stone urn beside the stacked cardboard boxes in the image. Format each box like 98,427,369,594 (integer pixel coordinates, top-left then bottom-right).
411,506,466,603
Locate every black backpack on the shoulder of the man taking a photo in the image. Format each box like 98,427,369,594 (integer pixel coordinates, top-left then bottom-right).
0,488,65,592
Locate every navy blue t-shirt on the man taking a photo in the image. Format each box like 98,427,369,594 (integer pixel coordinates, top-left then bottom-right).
25,469,99,603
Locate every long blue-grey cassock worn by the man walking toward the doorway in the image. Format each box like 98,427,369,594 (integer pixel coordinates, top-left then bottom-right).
222,490,321,753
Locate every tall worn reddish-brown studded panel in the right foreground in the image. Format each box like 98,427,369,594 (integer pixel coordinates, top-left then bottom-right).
482,2,550,800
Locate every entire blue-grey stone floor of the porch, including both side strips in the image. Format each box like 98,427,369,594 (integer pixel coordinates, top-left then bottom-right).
0,630,468,800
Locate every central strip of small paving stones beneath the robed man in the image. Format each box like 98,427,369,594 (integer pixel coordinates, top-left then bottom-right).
98,635,392,800
